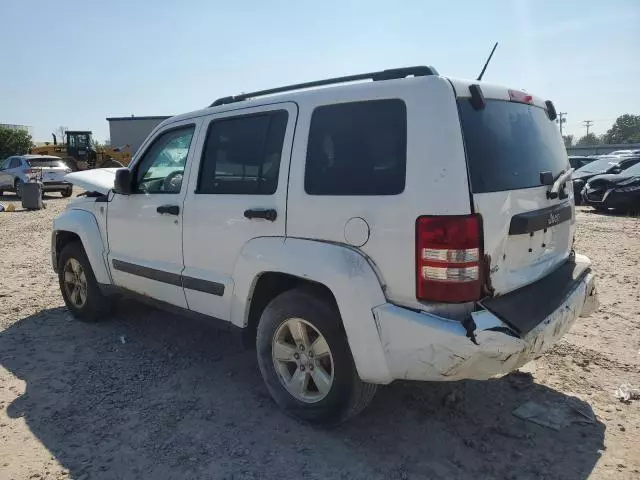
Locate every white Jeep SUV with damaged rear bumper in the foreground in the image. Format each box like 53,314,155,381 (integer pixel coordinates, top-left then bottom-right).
51,67,597,424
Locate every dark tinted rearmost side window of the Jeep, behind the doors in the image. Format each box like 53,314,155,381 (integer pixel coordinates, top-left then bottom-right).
304,99,407,195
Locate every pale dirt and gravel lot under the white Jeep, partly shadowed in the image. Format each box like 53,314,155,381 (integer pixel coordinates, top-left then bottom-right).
0,195,640,480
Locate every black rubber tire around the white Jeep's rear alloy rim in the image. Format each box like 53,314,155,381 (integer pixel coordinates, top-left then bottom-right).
256,288,377,426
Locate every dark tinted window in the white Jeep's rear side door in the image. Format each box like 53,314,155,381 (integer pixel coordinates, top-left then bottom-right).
196,110,289,195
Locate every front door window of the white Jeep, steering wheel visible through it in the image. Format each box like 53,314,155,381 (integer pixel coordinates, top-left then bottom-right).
135,125,195,193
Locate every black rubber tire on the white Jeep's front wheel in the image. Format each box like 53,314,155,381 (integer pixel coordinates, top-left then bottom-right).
58,242,111,322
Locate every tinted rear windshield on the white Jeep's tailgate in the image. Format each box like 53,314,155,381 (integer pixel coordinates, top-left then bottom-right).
458,98,569,193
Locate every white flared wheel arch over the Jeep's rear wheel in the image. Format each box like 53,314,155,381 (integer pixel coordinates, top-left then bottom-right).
231,237,392,383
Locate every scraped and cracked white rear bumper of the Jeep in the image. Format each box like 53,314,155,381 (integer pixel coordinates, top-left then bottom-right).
374,255,598,381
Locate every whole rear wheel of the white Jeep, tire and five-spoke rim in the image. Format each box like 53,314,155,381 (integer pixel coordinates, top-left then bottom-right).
256,288,376,425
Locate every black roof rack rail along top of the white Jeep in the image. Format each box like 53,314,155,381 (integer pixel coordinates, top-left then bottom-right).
209,65,438,107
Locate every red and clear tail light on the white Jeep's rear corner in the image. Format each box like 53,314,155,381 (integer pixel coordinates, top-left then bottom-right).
416,215,482,303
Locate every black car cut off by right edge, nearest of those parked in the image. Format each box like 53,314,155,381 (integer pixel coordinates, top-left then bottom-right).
582,157,640,212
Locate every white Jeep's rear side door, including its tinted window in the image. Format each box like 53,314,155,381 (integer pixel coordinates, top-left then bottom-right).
183,103,298,320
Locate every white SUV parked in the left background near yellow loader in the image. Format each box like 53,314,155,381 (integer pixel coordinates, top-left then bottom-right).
0,155,73,198
